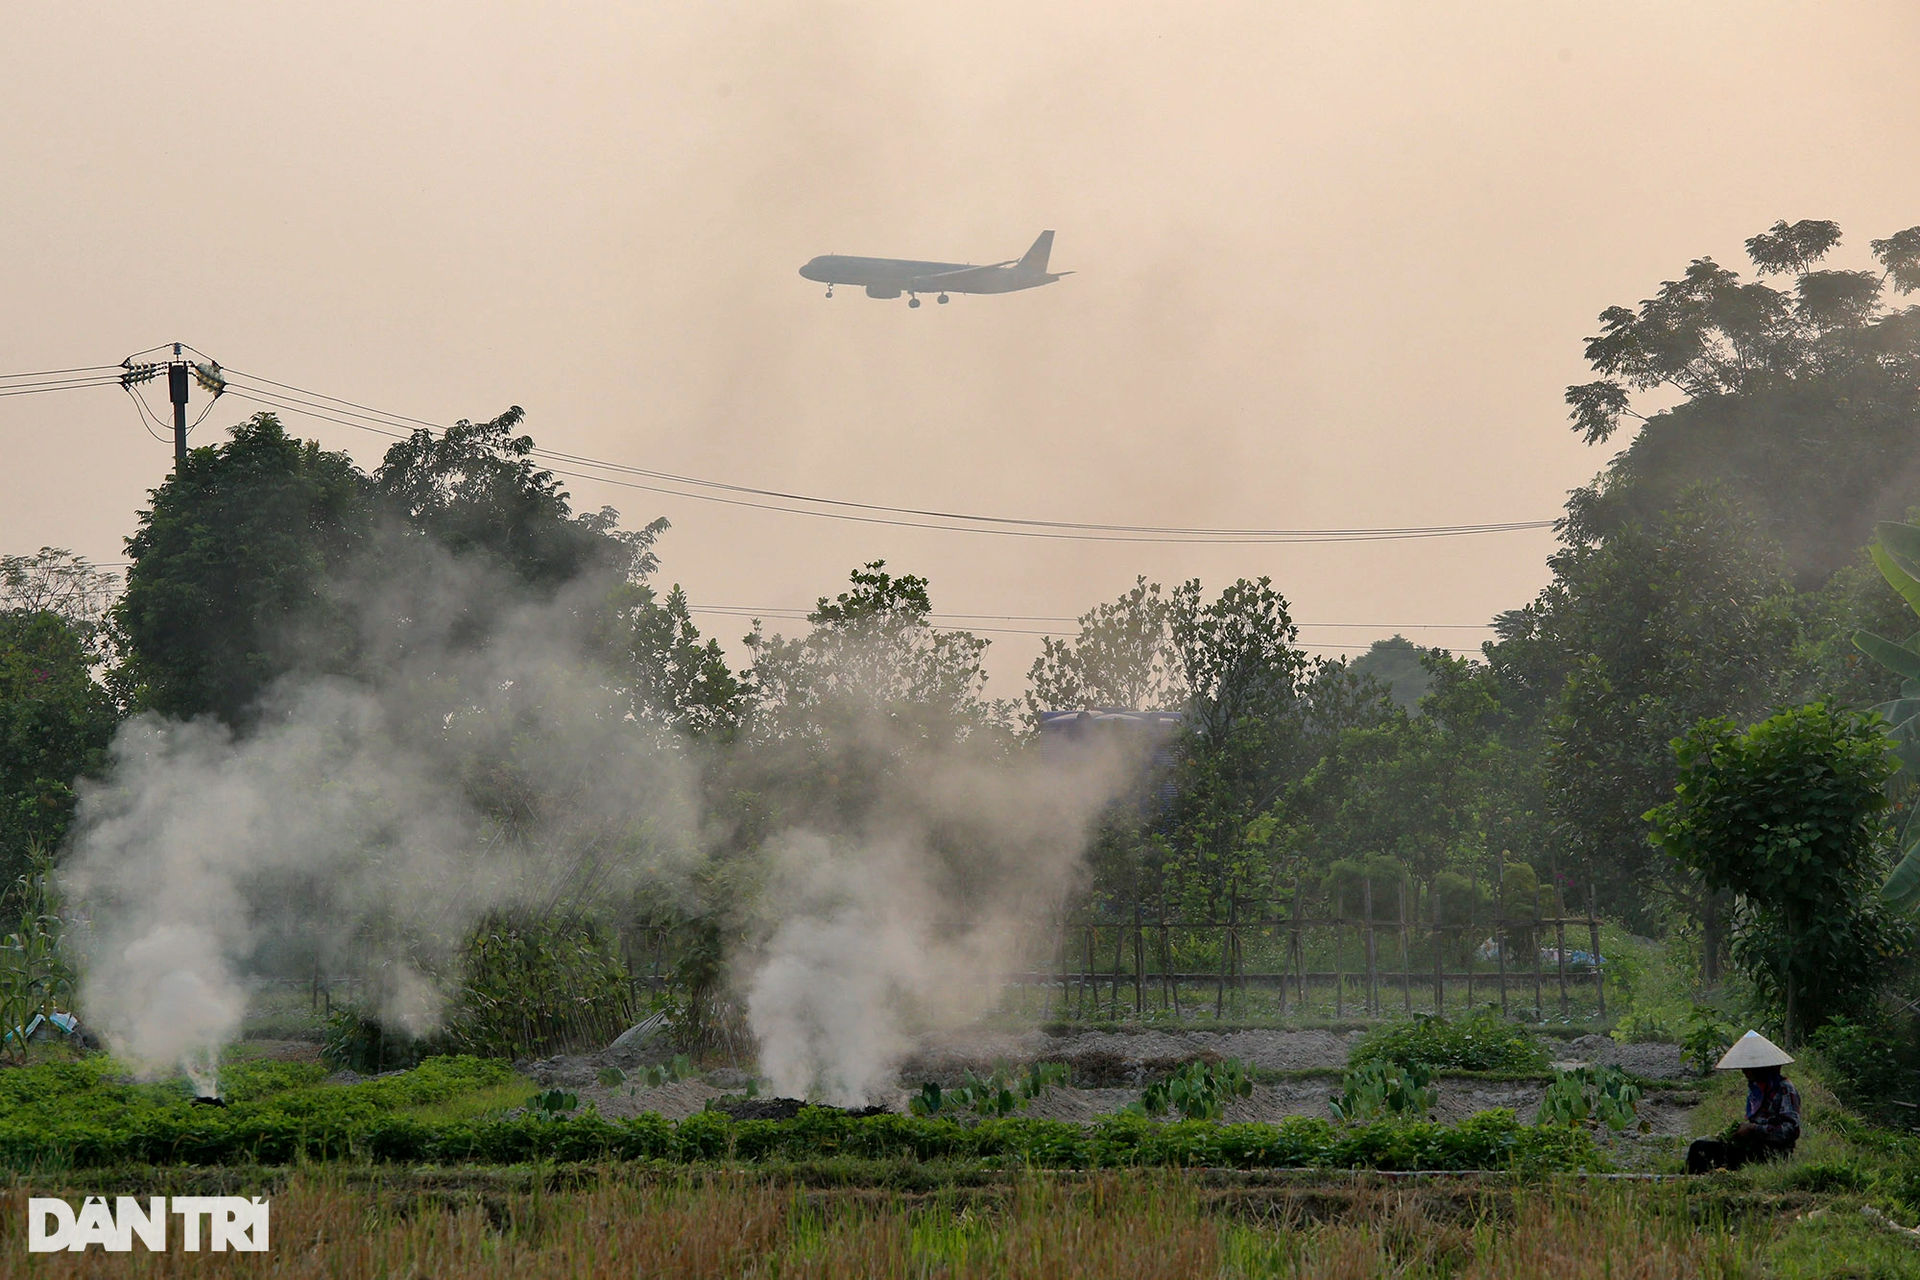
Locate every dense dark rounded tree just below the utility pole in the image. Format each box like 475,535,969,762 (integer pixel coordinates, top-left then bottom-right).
113,413,372,725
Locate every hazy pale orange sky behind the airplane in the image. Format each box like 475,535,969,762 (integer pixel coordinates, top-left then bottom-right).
0,0,1920,695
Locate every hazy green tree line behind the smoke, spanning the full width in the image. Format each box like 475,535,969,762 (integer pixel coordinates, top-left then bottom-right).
0,221,1920,1059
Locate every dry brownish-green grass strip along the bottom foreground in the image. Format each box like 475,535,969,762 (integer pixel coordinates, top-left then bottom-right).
0,1167,1920,1280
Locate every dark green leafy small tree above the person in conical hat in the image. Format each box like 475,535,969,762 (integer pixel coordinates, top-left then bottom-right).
1647,702,1907,1042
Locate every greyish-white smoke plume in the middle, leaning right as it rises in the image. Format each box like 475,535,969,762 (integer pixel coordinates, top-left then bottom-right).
743,725,1135,1105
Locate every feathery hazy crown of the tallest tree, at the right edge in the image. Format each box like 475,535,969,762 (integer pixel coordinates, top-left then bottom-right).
1567,221,1920,585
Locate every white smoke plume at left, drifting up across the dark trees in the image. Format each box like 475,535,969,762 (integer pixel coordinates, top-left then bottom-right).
61,558,697,1086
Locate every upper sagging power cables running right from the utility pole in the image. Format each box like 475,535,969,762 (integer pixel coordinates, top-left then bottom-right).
206,370,1553,545
